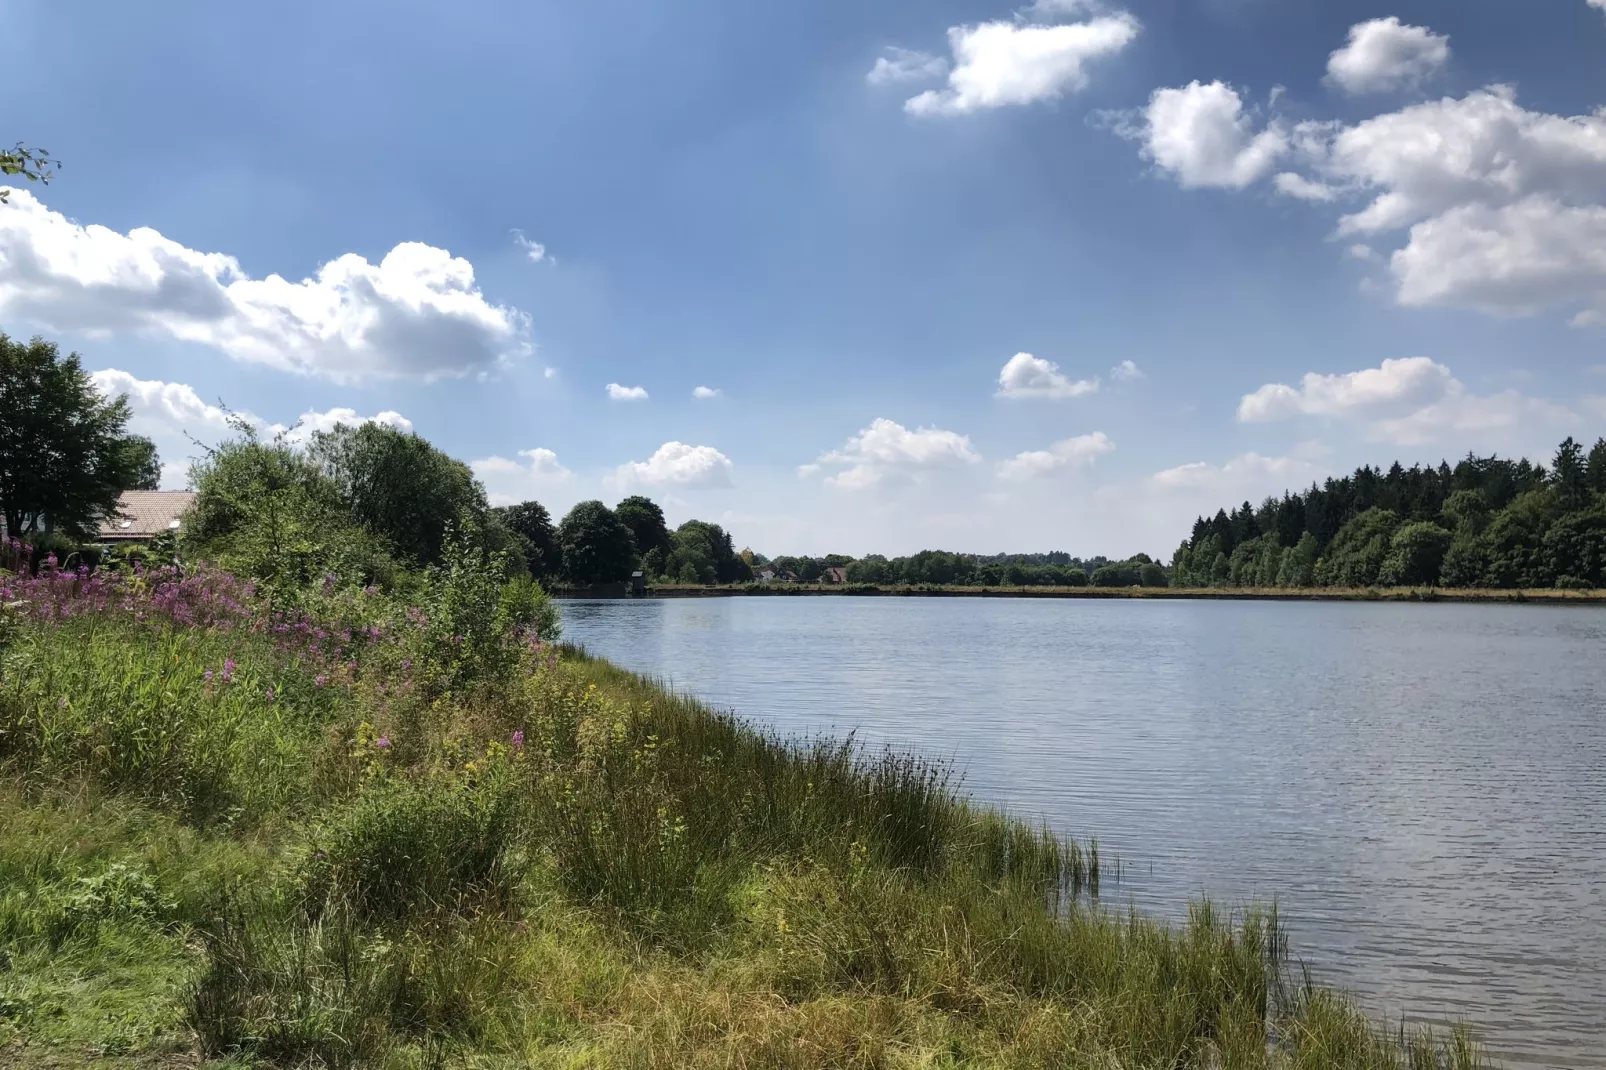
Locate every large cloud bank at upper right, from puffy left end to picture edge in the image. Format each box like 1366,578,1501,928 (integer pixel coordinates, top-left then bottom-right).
1111,77,1606,323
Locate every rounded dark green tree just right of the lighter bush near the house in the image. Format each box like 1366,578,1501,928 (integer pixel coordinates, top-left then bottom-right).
307,423,487,566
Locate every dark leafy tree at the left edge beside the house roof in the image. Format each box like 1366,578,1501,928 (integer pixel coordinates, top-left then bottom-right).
0,334,135,538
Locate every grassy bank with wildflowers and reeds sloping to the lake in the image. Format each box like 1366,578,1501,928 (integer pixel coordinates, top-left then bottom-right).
0,562,1482,1068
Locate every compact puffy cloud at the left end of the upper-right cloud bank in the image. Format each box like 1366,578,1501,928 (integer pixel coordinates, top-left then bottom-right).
1137,82,1290,190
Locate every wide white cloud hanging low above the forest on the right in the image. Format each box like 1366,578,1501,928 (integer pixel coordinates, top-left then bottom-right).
1238,357,1575,445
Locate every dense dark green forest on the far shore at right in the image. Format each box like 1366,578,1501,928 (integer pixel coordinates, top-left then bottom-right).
1171,437,1606,588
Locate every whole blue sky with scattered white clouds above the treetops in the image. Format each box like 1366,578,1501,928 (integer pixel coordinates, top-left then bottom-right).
0,0,1606,556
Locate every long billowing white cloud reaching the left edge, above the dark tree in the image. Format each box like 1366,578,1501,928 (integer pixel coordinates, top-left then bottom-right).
0,190,525,382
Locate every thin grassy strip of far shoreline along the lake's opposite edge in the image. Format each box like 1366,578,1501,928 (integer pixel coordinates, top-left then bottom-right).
552,583,1606,606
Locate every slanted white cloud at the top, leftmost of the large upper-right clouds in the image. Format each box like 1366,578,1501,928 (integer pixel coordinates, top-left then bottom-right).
904,11,1140,116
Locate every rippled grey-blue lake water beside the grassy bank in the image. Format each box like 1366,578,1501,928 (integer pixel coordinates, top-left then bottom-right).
564,598,1606,1068
